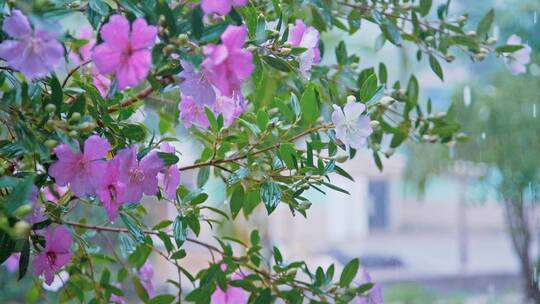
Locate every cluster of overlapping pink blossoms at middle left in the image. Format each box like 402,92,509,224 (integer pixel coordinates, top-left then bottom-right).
49,135,180,220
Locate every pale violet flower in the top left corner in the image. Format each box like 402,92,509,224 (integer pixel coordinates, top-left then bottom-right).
0,10,64,80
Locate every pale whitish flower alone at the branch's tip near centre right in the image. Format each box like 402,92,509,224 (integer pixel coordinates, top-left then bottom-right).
332,100,373,149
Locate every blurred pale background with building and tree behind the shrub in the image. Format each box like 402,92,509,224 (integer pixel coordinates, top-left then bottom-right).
0,0,540,304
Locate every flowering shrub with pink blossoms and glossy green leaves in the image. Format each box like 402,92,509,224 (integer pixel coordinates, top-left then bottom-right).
0,0,530,303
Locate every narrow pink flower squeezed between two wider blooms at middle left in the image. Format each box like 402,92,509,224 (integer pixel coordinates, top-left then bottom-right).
93,156,128,221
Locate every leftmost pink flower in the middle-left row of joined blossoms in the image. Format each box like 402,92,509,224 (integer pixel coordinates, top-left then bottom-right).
49,135,111,197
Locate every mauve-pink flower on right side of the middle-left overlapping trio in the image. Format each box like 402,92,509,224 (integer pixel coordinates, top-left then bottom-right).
116,146,164,203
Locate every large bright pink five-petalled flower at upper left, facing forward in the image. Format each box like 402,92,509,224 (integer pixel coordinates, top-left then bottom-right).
92,15,157,90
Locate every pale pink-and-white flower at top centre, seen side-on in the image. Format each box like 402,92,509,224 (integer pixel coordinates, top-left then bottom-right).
289,19,321,78
